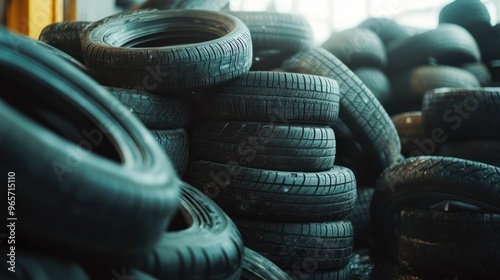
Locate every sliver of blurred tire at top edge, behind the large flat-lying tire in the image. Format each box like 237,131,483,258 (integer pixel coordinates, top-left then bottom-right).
141,0,230,11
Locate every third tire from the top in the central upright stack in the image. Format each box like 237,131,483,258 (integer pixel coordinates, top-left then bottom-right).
184,161,356,222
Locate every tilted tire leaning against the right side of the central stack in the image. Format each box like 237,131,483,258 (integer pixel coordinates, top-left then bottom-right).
284,48,401,181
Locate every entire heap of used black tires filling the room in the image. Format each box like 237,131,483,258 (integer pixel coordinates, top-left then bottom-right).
0,0,500,279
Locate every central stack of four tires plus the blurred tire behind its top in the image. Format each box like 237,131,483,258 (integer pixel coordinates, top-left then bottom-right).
185,11,356,279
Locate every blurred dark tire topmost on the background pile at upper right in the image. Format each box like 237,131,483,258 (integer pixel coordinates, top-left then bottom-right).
439,0,491,33
